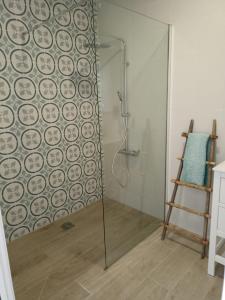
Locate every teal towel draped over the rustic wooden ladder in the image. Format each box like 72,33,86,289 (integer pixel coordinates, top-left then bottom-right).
181,133,209,185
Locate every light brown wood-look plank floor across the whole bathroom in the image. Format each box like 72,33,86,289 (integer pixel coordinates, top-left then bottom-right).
8,202,222,300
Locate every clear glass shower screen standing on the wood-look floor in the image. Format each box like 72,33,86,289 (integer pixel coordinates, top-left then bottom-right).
96,1,169,267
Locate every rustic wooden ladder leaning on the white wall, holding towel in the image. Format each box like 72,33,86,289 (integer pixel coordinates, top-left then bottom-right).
162,120,217,258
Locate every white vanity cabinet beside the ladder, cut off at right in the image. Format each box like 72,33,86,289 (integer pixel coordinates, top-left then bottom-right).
208,162,225,276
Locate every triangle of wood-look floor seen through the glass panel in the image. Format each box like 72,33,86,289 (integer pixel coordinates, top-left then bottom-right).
104,199,162,266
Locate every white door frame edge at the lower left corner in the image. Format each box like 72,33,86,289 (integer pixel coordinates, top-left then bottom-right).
0,208,16,300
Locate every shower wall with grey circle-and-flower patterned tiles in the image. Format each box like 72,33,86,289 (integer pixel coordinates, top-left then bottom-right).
0,0,101,240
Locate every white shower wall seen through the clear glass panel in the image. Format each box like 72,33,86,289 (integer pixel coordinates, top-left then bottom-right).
98,1,168,218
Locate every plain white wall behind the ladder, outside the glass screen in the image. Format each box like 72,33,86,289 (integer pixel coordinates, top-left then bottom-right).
104,0,225,233
